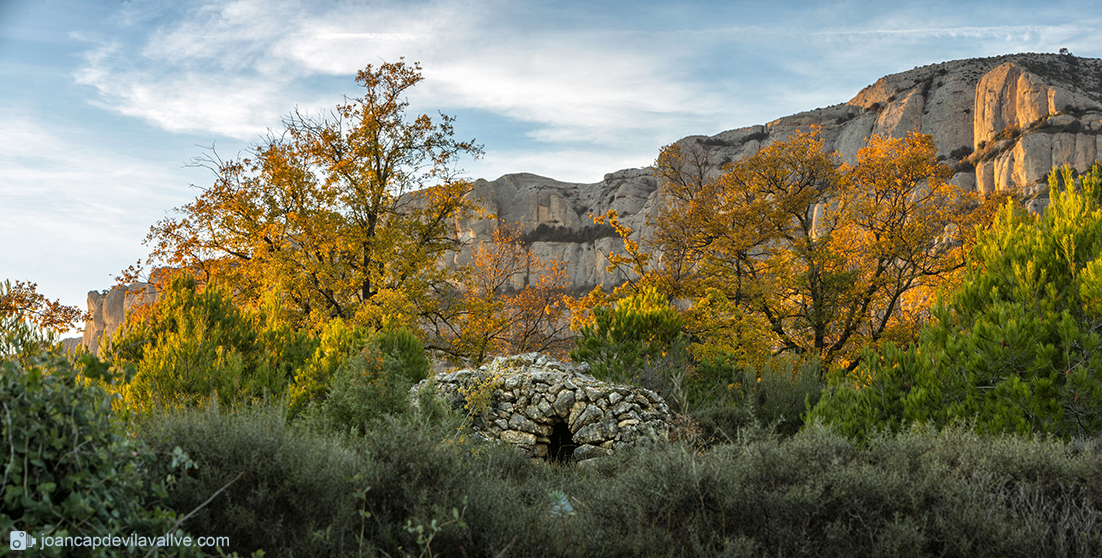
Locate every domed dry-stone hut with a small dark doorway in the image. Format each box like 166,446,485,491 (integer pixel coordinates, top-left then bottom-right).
411,353,669,461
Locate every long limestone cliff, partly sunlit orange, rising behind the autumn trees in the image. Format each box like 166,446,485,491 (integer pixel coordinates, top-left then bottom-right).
85,54,1102,346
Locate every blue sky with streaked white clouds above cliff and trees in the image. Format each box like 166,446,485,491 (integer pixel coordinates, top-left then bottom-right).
0,0,1102,333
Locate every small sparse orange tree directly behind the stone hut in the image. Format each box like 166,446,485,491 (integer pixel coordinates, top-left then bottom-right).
430,223,570,364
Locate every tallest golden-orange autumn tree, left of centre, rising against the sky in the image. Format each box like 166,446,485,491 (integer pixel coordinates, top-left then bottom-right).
147,61,482,326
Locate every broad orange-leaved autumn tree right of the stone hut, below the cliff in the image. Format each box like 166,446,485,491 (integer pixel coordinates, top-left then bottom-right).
613,130,972,365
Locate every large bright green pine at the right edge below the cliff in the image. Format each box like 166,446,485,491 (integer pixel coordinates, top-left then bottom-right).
812,167,1102,437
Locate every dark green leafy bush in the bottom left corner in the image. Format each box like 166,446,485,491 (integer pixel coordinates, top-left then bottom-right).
0,352,199,556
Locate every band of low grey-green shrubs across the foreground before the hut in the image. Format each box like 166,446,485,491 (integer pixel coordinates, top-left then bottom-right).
139,411,1102,557
